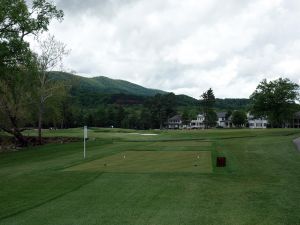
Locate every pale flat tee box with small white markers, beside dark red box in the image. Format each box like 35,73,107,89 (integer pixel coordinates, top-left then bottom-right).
66,151,212,173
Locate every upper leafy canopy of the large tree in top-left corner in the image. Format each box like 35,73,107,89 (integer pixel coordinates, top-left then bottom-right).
0,0,63,67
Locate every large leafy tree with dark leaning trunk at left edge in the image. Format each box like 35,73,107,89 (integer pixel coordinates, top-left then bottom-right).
0,0,63,145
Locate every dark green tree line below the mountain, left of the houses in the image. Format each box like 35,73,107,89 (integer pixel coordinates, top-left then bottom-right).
36,93,177,129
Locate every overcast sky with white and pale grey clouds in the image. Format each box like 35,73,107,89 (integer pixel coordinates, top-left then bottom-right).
43,0,300,98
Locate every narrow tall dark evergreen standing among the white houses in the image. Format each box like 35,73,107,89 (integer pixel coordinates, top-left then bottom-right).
200,88,218,128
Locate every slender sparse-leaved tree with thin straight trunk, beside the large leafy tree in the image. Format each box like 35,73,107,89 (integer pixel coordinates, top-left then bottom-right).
37,35,68,144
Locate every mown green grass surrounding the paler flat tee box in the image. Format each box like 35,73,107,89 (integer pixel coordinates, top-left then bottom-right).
0,129,300,225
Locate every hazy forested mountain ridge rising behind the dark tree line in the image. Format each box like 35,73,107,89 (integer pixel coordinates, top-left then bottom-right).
51,72,250,110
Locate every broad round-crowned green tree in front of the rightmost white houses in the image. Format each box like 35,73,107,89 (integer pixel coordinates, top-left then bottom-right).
250,78,299,127
